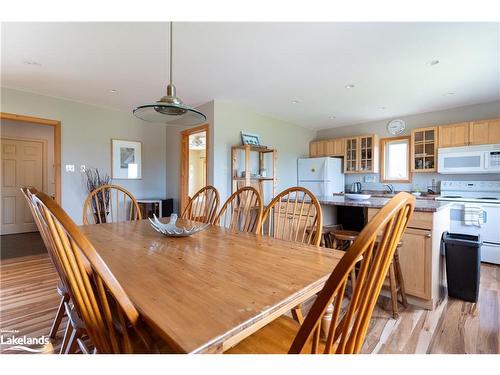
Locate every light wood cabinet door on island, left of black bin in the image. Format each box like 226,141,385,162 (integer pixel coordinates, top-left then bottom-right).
399,228,432,300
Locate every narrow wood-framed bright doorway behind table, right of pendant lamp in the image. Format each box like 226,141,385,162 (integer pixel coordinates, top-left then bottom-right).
179,125,208,213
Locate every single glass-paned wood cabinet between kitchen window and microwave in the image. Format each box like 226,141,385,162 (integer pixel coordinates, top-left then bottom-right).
411,127,438,172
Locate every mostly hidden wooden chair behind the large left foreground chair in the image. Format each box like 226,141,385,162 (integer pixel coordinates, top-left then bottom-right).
21,187,70,348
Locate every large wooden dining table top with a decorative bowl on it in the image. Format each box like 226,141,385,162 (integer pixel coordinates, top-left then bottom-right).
80,219,344,353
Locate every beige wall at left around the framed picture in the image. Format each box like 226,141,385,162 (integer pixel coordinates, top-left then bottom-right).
1,87,166,223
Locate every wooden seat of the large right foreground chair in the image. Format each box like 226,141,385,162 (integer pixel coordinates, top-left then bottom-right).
225,316,324,354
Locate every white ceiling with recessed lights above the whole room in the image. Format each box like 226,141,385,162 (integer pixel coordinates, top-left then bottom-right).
1,22,500,129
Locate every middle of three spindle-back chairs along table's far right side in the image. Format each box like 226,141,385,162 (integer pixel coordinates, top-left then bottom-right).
214,186,262,233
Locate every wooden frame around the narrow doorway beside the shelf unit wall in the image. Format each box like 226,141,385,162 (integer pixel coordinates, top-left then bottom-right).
179,124,210,214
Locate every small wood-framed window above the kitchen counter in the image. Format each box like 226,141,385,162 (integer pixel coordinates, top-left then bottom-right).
380,137,411,182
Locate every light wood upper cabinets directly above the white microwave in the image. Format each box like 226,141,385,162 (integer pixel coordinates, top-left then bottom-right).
439,119,500,147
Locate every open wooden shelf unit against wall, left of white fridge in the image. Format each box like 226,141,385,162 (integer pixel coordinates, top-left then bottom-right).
231,145,277,202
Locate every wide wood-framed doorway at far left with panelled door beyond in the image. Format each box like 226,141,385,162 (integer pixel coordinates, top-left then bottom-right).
0,112,61,259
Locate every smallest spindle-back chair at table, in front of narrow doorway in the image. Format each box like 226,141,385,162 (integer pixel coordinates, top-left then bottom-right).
181,185,219,224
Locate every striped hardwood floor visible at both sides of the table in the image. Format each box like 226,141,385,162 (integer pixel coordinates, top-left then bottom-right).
0,255,500,354
